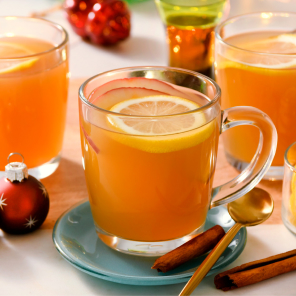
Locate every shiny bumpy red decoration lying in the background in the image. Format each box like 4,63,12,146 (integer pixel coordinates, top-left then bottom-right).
64,0,131,45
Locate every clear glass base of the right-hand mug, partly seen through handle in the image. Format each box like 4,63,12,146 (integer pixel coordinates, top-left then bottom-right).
225,151,284,181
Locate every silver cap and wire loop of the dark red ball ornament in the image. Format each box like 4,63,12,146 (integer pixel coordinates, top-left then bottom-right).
5,152,29,182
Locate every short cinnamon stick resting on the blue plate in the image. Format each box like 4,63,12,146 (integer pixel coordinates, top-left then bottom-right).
151,225,225,272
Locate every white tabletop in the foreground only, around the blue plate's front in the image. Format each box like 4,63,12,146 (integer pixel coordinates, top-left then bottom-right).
0,225,296,296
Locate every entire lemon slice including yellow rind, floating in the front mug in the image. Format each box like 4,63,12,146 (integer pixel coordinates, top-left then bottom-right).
108,96,215,153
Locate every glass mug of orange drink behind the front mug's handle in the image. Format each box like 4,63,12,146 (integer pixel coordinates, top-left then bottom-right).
215,12,296,180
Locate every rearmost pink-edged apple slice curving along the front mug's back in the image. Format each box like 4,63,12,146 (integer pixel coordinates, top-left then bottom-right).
88,77,190,103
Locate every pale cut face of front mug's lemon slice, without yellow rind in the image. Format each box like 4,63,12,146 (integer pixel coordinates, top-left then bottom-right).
109,96,205,136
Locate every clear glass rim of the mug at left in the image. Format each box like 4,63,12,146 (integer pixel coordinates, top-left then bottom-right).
0,16,69,61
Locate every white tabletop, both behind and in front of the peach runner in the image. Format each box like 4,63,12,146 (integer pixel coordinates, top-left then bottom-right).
0,0,296,296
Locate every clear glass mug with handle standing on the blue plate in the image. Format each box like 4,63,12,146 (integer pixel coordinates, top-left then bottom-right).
79,67,277,256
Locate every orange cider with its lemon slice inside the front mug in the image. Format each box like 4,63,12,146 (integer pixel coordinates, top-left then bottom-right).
81,84,219,241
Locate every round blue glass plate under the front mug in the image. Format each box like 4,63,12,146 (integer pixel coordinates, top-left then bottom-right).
53,201,247,285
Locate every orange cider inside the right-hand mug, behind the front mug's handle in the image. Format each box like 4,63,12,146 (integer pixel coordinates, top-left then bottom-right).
216,32,296,166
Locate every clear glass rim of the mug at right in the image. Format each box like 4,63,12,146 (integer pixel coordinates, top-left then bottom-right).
215,11,296,57
